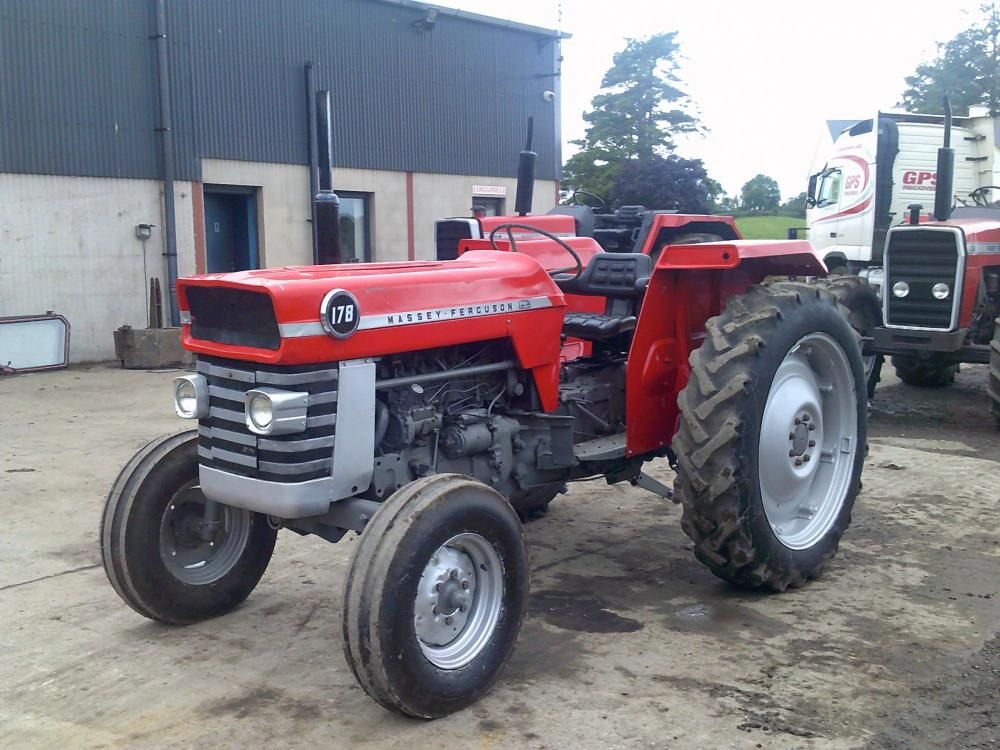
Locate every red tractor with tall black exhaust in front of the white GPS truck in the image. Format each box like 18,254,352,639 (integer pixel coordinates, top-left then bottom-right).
865,101,1000,426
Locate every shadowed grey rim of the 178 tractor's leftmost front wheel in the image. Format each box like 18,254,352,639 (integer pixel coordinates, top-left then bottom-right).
160,486,250,586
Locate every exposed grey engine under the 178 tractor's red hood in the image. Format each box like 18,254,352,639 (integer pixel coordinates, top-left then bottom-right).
366,341,625,505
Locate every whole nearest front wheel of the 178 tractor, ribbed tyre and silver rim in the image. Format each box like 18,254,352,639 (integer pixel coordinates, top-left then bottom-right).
343,474,528,719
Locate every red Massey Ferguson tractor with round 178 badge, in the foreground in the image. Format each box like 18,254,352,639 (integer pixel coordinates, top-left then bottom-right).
101,145,867,718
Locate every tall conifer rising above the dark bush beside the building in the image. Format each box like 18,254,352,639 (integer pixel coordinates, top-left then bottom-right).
563,32,699,196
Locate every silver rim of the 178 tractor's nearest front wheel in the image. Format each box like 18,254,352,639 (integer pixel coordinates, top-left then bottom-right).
413,532,504,669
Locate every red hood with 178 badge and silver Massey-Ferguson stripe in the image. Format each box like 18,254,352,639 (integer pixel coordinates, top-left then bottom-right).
177,250,565,366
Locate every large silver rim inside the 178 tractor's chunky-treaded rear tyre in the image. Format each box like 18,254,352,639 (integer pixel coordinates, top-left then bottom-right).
758,333,858,550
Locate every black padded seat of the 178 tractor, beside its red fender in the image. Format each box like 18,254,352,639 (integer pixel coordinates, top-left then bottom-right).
559,253,653,341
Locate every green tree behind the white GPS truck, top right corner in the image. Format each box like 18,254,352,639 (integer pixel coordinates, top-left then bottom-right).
900,2,1000,116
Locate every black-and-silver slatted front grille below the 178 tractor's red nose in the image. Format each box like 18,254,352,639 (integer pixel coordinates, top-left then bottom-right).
198,357,337,482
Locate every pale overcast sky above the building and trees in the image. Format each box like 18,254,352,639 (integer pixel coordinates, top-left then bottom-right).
448,0,978,199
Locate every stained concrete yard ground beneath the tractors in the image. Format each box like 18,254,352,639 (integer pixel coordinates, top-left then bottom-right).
0,366,1000,750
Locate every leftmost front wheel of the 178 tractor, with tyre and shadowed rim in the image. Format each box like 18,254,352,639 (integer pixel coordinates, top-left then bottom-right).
101,430,277,625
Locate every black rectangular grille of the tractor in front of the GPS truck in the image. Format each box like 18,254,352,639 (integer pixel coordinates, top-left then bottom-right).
883,229,962,331
